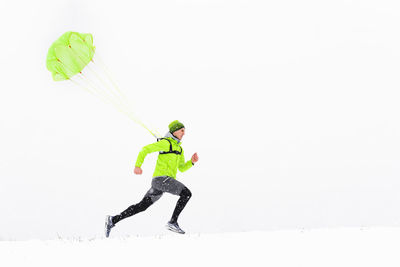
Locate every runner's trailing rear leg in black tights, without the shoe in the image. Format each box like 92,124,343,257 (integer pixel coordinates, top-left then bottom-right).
112,188,163,224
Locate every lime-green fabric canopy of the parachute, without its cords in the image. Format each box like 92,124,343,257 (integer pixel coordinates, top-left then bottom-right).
46,32,95,81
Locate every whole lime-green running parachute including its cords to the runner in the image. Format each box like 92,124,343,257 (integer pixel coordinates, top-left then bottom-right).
46,31,160,138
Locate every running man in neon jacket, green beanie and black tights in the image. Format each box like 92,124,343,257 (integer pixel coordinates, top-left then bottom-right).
105,120,199,237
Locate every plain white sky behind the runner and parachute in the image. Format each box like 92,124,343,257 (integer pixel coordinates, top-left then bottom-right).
0,0,400,240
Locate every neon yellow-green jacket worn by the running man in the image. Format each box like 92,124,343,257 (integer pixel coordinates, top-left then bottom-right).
135,133,193,179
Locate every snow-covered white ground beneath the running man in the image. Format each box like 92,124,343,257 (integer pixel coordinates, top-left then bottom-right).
0,227,400,267
